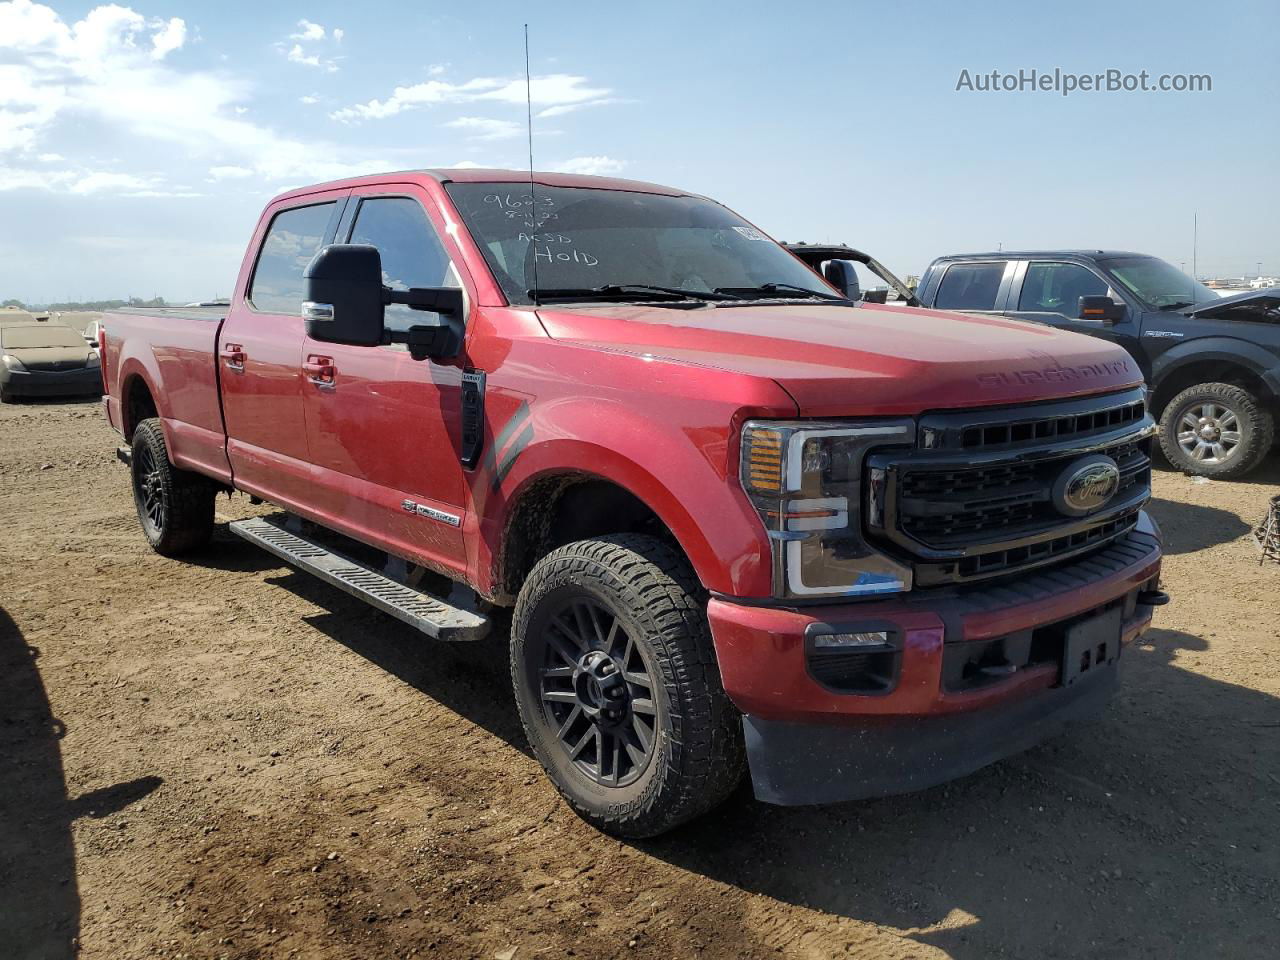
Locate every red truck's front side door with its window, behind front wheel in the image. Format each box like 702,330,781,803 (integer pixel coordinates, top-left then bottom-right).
302,186,466,577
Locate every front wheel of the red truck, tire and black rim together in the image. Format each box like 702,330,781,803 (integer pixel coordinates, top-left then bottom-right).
511,534,744,837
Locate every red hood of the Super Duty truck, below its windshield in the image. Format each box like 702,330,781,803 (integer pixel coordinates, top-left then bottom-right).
538,303,1142,416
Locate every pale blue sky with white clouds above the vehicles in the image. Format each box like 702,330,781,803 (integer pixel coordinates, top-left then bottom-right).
0,0,1280,302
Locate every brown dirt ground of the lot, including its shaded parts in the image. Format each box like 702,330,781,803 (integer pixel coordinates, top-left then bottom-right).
0,403,1280,960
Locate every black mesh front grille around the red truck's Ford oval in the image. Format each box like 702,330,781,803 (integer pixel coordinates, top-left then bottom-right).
867,389,1155,586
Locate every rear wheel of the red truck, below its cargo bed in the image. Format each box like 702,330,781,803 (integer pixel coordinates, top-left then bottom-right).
129,417,216,557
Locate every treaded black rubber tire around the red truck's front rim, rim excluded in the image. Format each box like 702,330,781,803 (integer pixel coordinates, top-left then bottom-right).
511,534,745,838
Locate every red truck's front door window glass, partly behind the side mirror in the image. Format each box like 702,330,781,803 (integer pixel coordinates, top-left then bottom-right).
351,197,461,330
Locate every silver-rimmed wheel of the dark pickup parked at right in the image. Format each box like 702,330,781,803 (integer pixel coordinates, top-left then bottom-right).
1160,383,1275,480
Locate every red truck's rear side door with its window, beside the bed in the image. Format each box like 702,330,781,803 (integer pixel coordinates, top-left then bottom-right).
218,191,348,508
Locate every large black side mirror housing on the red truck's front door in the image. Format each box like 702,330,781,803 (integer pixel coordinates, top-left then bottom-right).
302,243,384,347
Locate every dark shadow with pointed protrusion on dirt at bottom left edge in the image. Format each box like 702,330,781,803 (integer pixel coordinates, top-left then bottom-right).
0,608,161,960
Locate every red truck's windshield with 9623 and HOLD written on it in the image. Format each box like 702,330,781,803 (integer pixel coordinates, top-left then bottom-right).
447,183,833,303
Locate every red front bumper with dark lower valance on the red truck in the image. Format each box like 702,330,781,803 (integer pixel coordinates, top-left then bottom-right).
708,513,1160,804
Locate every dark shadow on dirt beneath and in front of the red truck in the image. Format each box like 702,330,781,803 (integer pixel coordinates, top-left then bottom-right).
241,560,1280,960
